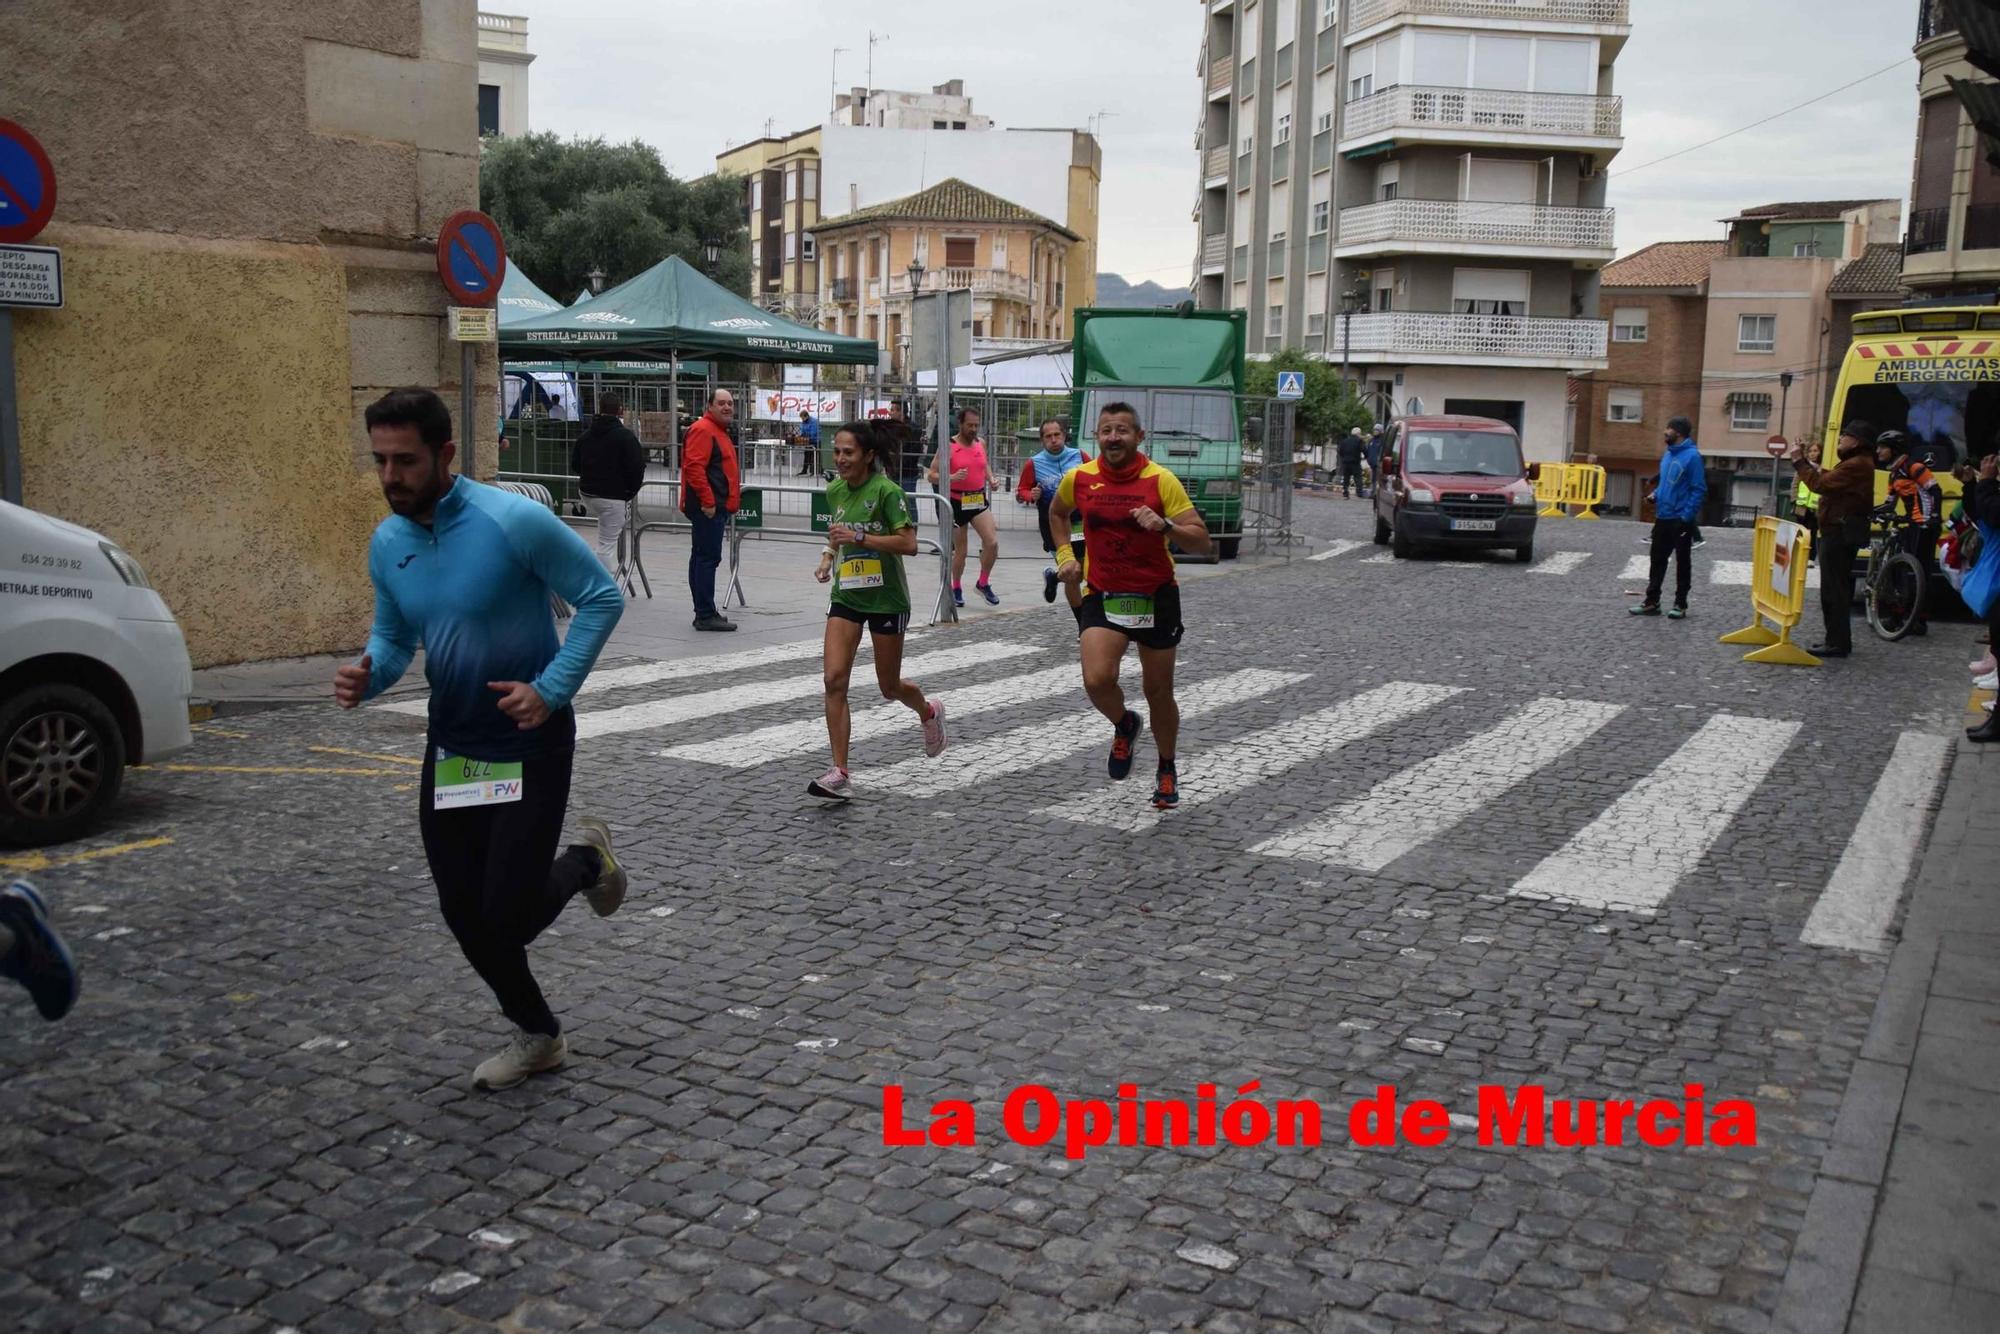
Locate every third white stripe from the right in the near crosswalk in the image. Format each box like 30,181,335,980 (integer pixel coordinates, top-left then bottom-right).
1250,696,1624,870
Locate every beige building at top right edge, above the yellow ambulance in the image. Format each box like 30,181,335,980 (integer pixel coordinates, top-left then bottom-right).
1902,0,2000,304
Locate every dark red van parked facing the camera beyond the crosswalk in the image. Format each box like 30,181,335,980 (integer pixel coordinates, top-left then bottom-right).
1374,416,1540,564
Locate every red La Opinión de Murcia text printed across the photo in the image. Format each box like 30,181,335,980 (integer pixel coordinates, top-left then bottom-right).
882,1080,1756,1158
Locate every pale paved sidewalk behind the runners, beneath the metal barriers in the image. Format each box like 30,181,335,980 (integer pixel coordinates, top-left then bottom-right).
194,524,1322,720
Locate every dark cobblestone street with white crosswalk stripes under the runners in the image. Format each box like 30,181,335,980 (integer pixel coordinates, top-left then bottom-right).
0,498,1972,1334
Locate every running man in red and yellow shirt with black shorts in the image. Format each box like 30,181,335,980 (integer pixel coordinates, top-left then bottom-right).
1048,402,1208,810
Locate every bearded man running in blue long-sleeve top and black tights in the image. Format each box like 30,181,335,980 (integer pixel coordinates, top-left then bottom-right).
334,390,626,1088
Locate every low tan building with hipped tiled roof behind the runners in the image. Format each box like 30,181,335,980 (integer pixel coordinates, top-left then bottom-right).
814,180,1082,376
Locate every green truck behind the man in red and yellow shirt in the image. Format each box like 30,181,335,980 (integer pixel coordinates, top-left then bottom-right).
1070,306,1248,560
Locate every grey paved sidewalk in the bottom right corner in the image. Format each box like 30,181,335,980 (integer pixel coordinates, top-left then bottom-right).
1778,700,2000,1334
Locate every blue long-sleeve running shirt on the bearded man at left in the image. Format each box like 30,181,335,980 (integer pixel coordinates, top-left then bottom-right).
366,478,624,760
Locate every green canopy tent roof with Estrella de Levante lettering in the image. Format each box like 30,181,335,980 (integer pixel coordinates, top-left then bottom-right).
500,256,880,366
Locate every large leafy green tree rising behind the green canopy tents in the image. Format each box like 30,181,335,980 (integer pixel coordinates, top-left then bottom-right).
480,132,750,300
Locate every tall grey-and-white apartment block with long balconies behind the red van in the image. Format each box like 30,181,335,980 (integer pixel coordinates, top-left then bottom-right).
1194,0,1632,458
